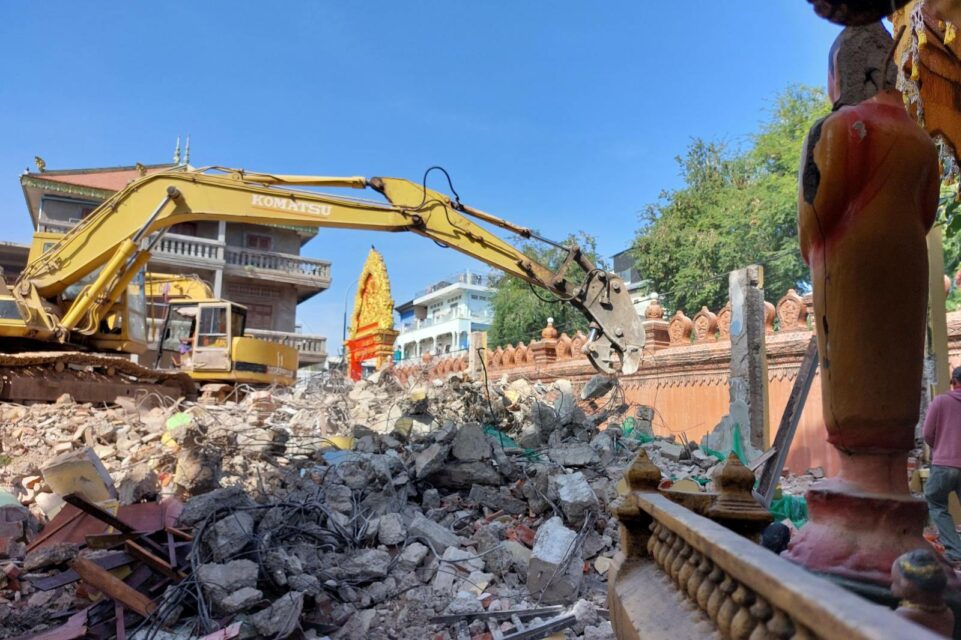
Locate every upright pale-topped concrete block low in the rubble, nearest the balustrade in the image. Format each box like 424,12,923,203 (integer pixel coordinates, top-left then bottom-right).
527,516,583,604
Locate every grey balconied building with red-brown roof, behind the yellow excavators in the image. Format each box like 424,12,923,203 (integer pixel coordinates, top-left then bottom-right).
20,164,330,366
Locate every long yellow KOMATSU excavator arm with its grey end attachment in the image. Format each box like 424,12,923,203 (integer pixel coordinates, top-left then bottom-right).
15,168,643,372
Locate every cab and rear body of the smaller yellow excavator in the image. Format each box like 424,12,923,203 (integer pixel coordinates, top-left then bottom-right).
155,300,297,384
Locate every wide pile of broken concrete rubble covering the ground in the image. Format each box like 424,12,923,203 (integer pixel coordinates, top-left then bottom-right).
0,374,808,640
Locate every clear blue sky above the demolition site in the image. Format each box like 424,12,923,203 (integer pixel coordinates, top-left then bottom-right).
0,0,838,353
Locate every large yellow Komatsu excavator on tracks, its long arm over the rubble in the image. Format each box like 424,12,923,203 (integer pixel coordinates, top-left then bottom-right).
0,167,644,402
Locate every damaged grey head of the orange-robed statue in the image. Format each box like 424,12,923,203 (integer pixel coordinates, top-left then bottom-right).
828,22,898,109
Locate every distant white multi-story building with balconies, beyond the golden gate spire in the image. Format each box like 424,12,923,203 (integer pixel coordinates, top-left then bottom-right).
394,271,494,360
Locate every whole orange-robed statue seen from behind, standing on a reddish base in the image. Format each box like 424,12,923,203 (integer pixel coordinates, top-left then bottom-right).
785,24,939,584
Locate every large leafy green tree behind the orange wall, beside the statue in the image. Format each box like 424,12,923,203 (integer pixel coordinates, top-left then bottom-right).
634,86,830,313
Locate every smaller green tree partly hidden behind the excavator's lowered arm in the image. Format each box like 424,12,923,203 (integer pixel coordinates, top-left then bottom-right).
488,231,608,348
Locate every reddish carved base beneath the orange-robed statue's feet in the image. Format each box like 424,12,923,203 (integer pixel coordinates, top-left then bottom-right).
783,478,928,586
